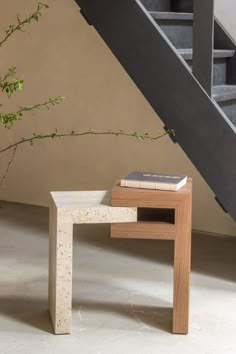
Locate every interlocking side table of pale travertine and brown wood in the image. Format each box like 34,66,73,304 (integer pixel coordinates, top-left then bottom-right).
49,179,192,334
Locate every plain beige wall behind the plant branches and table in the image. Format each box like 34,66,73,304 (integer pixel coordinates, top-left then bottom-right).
0,0,236,235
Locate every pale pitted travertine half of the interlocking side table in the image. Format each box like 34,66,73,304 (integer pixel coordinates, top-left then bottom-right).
49,191,137,334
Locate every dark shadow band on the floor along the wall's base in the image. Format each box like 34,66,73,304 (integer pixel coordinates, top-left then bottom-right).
0,201,236,282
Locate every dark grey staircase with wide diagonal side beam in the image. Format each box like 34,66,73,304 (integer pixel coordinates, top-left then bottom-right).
76,0,236,220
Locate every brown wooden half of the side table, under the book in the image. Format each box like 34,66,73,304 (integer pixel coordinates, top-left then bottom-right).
111,179,192,334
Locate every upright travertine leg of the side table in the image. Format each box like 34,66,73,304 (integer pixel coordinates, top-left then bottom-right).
49,201,73,334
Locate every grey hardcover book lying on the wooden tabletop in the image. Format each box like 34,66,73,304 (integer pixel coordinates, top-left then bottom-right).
120,171,187,191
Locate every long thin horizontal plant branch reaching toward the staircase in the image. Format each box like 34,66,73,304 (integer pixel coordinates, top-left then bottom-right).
0,130,174,153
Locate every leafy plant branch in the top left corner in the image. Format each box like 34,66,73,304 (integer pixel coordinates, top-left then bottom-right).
0,2,49,48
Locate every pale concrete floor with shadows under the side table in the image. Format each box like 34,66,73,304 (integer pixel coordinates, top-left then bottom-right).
0,202,236,354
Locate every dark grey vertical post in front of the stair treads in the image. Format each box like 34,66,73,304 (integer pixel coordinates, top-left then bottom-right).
193,0,214,97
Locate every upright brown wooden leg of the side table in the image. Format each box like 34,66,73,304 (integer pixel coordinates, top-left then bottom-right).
173,195,192,334
